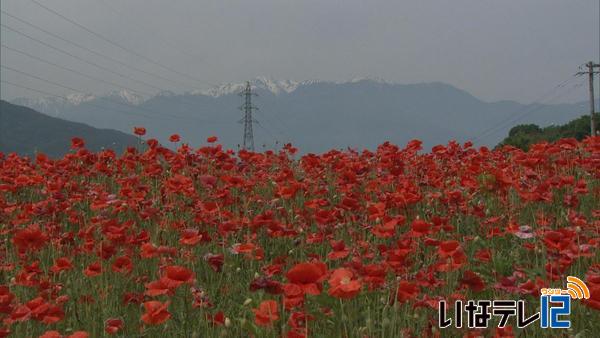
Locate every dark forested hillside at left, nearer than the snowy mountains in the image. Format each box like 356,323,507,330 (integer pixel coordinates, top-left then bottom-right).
0,100,139,158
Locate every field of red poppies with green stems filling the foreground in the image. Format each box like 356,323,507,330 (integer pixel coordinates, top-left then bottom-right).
0,137,600,337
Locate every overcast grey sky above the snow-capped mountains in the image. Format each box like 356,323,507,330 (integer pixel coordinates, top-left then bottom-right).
0,0,600,102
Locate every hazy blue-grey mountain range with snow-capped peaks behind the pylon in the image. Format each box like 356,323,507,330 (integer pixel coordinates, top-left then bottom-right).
12,78,587,152
